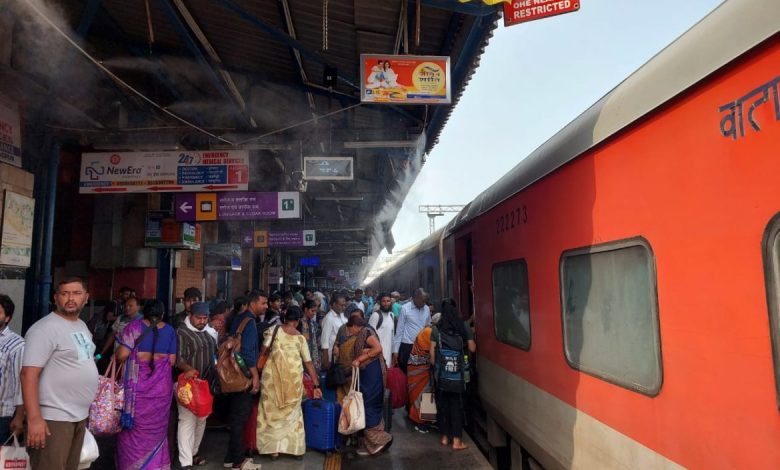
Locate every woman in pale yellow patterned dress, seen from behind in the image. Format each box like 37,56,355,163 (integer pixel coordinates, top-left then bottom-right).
257,306,322,459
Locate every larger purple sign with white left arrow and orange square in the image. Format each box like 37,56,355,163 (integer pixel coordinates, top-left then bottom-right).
175,191,301,222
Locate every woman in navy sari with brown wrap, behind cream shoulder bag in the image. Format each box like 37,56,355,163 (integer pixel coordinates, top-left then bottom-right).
335,314,393,456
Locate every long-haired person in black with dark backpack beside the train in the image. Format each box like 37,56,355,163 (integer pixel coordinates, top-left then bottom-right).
431,299,477,450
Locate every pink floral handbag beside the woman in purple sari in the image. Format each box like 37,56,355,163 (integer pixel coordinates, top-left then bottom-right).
87,356,125,436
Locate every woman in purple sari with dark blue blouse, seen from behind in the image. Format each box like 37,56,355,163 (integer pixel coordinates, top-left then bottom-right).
116,300,176,470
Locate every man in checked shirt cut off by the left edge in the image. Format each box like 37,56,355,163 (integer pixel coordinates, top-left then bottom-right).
0,294,24,443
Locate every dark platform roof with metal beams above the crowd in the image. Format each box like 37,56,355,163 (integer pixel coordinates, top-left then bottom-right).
0,0,498,278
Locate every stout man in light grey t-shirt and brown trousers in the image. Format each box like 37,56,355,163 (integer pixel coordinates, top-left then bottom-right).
21,278,98,470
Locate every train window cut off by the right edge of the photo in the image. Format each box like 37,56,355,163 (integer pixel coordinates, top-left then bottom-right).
763,214,780,408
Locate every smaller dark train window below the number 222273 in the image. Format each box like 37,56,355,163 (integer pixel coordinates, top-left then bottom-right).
493,259,531,351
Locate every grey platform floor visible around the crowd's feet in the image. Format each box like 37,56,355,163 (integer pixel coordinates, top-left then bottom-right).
90,409,491,470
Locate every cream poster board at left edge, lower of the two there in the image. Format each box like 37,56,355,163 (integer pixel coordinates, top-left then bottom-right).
0,190,35,268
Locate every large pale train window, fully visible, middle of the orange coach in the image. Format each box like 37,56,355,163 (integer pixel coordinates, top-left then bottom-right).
560,238,663,396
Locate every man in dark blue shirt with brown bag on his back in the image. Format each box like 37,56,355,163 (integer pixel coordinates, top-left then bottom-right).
220,290,268,470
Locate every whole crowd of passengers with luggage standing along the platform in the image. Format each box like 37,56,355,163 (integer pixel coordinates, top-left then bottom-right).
0,278,476,470
